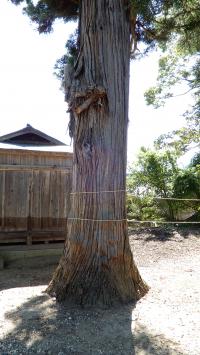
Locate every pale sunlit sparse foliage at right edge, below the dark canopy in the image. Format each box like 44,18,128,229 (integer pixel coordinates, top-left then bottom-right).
145,49,200,155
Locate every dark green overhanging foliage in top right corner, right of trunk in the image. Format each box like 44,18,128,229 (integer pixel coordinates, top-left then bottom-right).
130,0,200,53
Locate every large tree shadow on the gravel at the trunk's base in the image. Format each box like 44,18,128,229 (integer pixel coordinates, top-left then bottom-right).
0,294,183,355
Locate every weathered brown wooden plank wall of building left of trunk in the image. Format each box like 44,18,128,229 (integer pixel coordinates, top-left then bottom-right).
0,149,72,244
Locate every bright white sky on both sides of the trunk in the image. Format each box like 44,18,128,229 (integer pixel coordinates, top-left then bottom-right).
0,0,194,163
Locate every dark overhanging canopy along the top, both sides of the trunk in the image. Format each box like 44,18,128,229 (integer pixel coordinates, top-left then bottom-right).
11,0,200,50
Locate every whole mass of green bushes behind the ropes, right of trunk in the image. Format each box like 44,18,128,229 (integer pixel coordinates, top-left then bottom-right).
127,148,200,221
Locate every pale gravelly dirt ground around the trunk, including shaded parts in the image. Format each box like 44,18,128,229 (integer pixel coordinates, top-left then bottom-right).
0,228,200,355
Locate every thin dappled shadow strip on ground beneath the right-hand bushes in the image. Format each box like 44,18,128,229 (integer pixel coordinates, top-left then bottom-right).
129,226,200,242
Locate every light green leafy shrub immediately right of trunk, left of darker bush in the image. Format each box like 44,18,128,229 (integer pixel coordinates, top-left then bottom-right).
128,147,179,221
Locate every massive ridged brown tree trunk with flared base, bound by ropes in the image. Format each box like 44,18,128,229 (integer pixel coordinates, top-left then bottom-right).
47,0,148,304
